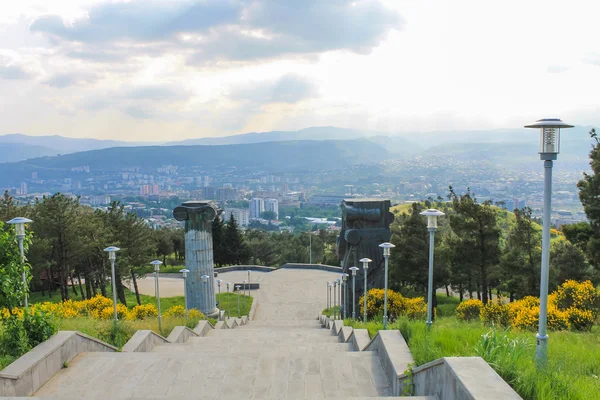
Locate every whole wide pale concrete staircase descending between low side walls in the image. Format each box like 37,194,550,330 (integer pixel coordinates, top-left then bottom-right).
35,320,433,399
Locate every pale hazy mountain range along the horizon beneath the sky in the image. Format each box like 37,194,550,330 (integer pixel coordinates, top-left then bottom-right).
0,126,591,163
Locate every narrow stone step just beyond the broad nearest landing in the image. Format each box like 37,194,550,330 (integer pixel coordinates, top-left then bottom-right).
152,340,352,354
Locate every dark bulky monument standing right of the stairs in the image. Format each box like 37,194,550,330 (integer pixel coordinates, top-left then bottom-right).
337,199,394,315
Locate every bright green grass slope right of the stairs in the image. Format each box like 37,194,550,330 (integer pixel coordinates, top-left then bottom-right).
347,317,600,400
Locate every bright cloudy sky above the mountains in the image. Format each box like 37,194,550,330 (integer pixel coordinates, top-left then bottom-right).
0,0,600,142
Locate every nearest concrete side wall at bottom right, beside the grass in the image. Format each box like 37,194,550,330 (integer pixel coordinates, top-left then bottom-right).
399,357,522,400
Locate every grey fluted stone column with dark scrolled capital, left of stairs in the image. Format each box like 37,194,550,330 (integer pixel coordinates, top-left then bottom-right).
173,201,219,317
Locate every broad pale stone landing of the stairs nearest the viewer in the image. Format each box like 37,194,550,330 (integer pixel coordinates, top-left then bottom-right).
35,352,391,399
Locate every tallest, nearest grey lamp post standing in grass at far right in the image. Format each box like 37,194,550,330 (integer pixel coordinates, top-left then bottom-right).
525,118,573,367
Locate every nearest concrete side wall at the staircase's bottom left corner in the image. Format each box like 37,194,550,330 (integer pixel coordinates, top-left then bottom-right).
0,331,117,396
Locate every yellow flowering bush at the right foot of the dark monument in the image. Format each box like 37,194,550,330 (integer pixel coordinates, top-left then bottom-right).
359,288,427,320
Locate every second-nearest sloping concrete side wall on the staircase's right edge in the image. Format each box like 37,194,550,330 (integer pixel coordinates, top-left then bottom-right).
364,330,414,400
